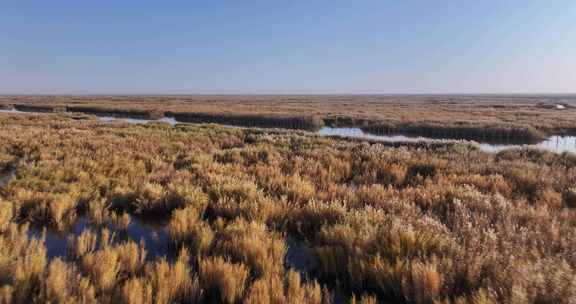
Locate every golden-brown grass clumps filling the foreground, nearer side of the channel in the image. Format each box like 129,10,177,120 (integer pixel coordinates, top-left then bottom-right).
0,114,576,303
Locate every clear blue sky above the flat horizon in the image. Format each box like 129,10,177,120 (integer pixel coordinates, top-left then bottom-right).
0,0,576,94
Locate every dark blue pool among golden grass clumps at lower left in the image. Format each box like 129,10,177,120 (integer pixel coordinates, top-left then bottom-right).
29,216,171,260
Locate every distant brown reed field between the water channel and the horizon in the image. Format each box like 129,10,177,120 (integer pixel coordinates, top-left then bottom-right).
6,96,576,141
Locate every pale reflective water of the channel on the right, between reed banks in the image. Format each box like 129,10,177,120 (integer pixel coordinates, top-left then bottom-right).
318,127,576,153
